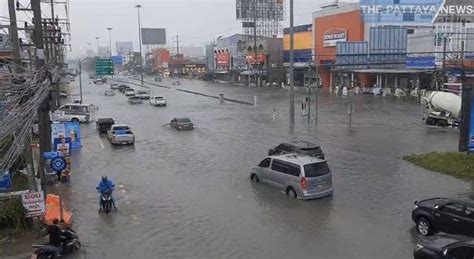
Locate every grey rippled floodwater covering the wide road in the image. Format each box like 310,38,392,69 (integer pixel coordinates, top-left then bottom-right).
49,76,472,258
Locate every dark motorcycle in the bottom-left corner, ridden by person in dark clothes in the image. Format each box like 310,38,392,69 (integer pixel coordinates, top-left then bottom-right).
31,228,82,259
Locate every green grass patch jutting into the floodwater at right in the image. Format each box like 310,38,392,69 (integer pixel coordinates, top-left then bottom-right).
403,152,474,180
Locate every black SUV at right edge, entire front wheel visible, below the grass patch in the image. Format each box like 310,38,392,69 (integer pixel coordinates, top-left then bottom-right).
411,197,474,239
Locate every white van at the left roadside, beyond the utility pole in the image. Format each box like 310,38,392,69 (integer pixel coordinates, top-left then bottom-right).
51,103,98,122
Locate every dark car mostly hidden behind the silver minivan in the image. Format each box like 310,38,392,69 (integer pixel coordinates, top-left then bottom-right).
268,140,325,159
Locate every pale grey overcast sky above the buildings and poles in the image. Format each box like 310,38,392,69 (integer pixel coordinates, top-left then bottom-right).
0,0,354,56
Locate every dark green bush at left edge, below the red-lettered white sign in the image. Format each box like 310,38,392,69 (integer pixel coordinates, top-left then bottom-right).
0,198,32,231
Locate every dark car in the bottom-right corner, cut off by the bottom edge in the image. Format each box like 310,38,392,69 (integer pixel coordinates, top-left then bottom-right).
413,234,474,259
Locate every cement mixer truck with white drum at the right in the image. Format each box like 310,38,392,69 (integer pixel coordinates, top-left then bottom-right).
424,91,461,127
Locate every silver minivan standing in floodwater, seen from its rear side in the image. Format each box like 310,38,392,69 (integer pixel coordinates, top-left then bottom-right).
250,154,333,199
